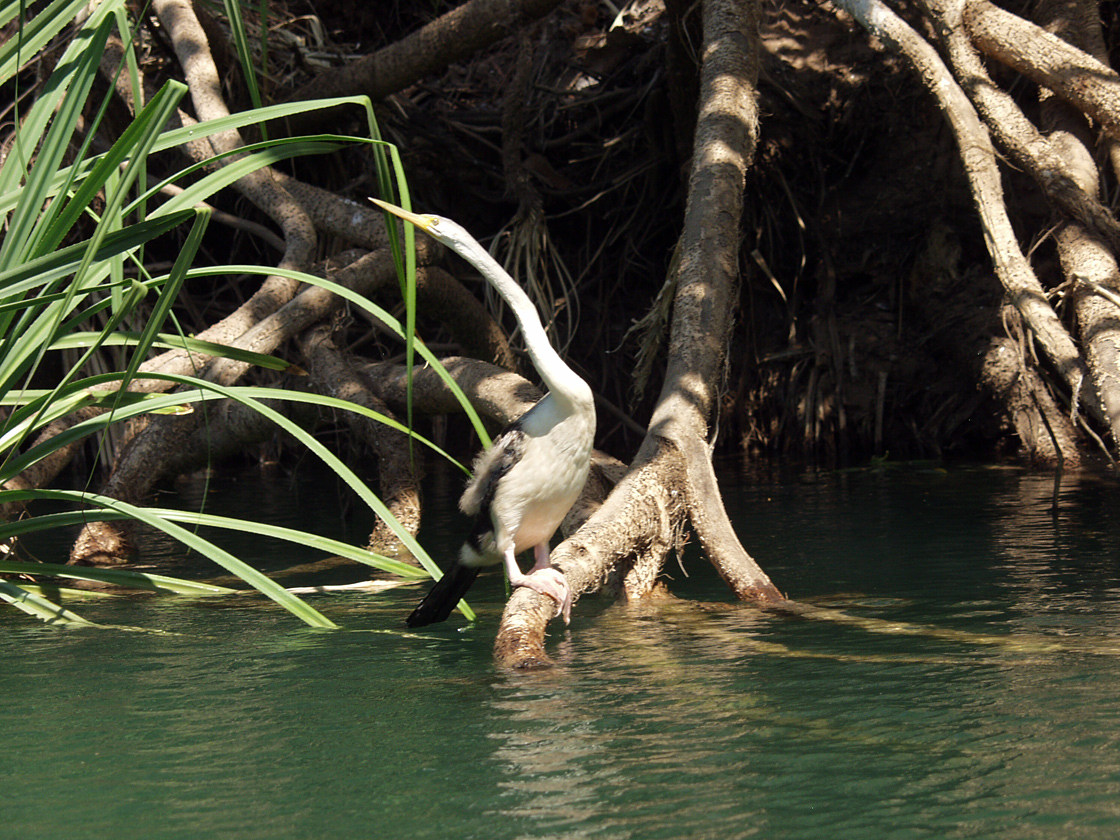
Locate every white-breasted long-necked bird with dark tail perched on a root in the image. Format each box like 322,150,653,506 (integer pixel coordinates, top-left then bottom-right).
370,198,595,627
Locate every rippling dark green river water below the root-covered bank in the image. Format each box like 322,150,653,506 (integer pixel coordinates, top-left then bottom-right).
0,467,1120,840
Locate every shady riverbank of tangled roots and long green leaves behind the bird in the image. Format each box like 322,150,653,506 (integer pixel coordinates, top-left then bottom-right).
0,0,1120,664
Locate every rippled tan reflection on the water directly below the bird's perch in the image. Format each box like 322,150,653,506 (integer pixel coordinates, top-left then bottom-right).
489,604,779,838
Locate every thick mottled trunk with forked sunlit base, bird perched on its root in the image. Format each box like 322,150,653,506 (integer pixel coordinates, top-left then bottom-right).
495,1,782,668
